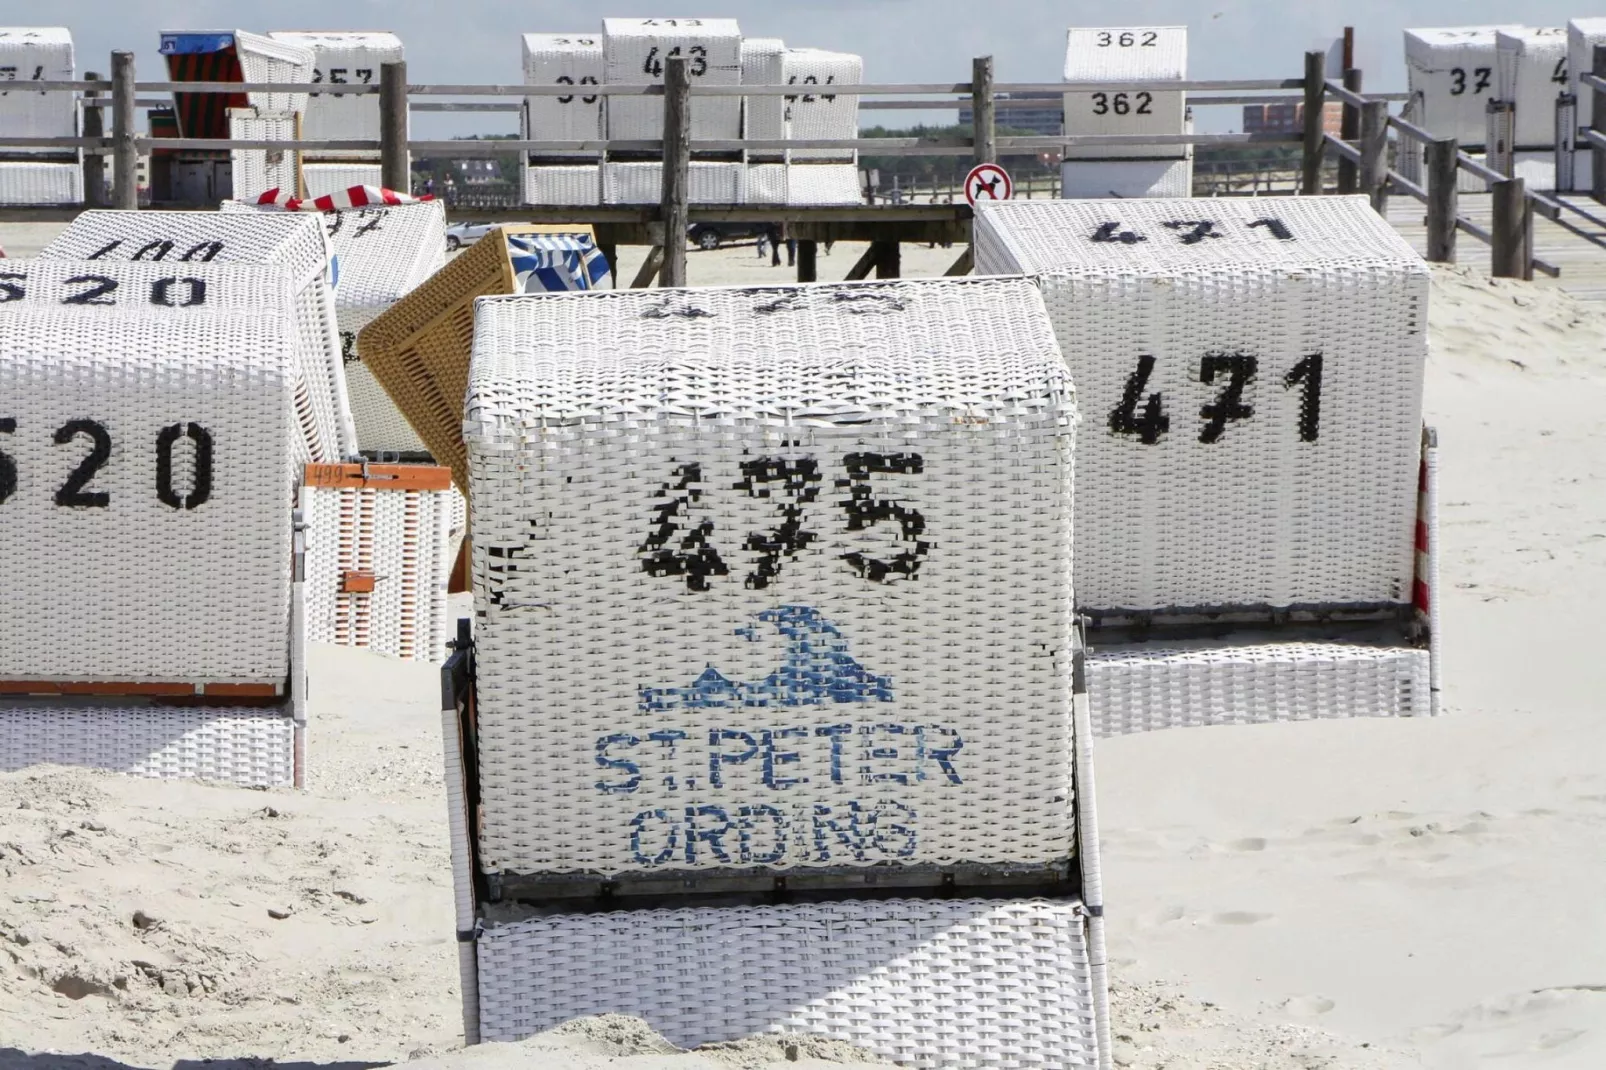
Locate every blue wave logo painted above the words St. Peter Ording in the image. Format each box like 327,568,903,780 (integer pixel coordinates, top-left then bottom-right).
641,606,893,713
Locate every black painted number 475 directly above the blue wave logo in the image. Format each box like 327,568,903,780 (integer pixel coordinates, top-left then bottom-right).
639,453,931,591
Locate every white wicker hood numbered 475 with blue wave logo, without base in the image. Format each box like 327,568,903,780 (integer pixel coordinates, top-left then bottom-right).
464,280,1074,874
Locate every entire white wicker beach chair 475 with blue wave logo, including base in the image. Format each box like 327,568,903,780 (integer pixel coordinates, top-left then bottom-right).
445,280,1108,1067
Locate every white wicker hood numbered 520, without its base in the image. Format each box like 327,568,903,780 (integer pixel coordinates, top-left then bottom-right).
0,260,300,681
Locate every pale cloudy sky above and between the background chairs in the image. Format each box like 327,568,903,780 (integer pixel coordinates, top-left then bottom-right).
31,0,1606,137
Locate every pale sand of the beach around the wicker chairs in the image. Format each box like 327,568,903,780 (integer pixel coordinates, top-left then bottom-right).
0,225,1606,1070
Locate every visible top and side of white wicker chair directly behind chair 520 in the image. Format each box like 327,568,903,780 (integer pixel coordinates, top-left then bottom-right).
39,210,357,461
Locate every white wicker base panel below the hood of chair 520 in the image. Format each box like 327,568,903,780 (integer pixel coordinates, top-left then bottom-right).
0,702,296,787
